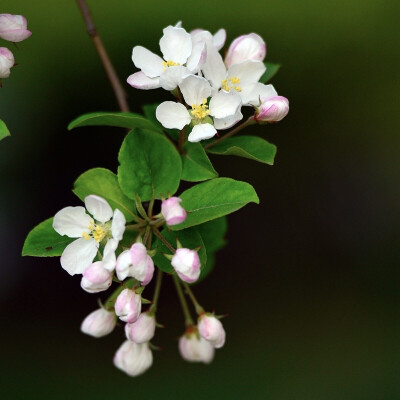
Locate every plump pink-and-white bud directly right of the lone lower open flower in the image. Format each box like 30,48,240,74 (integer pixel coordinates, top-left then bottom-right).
116,243,154,285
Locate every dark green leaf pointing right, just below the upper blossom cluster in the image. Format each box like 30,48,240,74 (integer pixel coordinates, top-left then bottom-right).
207,135,276,165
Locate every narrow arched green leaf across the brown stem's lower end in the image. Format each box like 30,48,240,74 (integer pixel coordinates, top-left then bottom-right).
68,112,160,131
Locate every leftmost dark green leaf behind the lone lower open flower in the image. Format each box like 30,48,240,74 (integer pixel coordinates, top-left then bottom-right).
22,218,76,257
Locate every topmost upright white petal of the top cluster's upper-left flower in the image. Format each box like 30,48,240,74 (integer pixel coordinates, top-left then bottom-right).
159,25,192,64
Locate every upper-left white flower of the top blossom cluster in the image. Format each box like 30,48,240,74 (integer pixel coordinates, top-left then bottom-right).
127,25,207,90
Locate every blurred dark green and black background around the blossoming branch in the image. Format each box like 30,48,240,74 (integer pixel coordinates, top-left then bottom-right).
0,0,400,400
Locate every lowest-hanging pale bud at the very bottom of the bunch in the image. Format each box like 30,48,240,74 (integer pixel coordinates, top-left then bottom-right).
114,340,153,376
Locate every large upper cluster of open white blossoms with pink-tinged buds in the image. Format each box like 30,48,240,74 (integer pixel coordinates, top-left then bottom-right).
127,23,289,142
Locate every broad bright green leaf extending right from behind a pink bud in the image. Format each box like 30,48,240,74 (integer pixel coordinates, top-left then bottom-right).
170,178,259,230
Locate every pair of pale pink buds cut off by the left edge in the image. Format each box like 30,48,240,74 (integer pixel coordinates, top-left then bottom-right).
0,14,32,82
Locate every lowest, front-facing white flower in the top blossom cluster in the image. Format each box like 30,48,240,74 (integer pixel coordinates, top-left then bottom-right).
156,75,243,142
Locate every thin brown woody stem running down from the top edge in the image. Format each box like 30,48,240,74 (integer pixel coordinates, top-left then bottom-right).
77,0,129,111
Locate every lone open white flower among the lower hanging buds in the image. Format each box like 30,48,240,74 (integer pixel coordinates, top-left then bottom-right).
53,195,126,275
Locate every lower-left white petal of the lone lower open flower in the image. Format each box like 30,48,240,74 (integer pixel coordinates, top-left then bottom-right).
60,238,98,275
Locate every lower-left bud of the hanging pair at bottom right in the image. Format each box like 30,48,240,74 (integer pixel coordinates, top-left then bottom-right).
179,332,215,364
